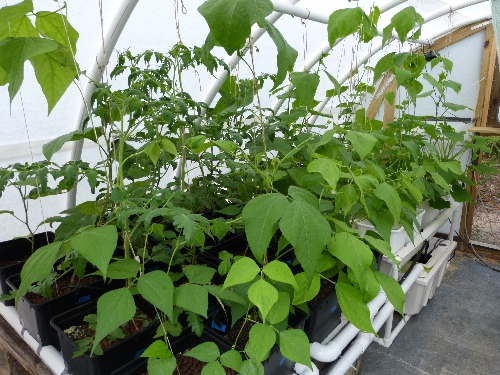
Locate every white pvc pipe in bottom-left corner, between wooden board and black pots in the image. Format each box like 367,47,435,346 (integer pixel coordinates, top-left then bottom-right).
0,304,66,375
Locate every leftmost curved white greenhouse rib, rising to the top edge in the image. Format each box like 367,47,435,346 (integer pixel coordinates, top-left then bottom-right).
66,0,139,208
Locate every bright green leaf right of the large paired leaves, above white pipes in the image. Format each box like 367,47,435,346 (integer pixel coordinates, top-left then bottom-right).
328,232,373,286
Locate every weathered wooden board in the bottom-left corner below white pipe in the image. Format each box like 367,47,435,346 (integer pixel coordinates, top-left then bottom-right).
0,316,54,375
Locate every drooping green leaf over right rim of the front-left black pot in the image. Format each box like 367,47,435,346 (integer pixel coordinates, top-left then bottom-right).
137,270,174,319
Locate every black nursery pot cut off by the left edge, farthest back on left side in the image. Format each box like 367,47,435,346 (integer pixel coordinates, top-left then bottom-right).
0,232,55,306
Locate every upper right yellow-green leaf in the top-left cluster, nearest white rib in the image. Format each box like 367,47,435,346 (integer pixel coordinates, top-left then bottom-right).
36,11,79,50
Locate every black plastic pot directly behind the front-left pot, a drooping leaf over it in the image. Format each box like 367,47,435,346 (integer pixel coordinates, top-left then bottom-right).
7,274,110,350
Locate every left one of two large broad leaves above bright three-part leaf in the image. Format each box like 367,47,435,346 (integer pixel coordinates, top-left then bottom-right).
241,193,290,263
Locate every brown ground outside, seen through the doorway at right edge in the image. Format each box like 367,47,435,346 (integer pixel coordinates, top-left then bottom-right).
469,160,500,246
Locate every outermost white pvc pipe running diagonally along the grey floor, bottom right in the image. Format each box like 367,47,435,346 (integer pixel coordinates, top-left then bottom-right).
327,264,424,375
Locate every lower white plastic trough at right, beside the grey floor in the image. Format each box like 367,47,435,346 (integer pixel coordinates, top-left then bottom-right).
404,238,457,315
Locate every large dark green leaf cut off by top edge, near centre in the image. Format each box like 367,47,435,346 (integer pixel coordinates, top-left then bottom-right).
198,0,273,55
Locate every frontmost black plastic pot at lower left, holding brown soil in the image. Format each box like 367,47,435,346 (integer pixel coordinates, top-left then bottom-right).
50,296,159,375
